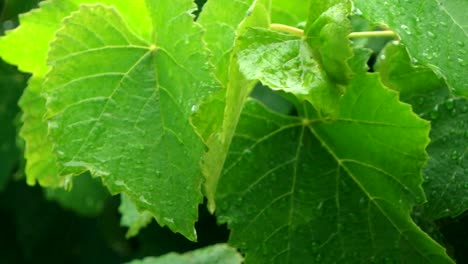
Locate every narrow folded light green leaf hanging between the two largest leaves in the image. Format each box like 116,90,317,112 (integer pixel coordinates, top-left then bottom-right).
197,0,271,212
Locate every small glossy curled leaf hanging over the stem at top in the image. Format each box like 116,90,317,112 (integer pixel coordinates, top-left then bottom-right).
305,0,353,84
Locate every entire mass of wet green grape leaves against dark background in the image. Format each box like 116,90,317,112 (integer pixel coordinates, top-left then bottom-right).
0,0,468,263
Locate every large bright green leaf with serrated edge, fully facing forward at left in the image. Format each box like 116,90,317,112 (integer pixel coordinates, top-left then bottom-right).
43,3,217,240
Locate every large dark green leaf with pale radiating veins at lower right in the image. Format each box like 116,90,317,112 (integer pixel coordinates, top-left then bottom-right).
217,74,452,263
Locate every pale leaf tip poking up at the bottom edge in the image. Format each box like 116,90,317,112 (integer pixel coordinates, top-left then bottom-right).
129,244,242,264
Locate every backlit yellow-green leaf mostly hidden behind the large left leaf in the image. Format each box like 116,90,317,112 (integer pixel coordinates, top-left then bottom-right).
0,0,150,187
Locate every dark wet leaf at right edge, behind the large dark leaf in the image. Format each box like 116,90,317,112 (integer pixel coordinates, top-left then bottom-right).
375,43,468,220
